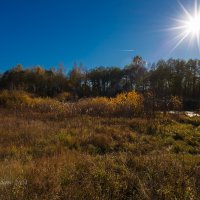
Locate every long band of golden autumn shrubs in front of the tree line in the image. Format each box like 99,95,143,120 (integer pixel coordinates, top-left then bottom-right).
0,90,182,117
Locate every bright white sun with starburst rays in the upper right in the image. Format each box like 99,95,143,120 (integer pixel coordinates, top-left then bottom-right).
170,0,200,51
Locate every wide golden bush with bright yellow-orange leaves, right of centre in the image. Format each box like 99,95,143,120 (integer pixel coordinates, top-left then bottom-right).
77,92,143,117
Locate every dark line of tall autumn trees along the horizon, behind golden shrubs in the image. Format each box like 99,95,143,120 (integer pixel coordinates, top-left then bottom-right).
0,56,200,109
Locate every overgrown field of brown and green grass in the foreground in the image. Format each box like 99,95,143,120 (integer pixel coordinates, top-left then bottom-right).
0,91,200,200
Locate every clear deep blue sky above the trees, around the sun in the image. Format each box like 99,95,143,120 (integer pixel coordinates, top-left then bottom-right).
0,0,200,72
